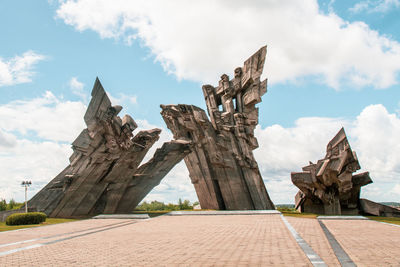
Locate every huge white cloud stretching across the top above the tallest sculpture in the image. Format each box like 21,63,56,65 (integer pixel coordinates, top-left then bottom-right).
57,0,400,88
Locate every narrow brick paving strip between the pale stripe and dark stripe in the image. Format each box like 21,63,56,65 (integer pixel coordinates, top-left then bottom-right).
286,216,340,266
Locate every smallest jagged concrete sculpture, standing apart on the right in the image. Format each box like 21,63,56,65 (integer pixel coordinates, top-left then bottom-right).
291,128,372,215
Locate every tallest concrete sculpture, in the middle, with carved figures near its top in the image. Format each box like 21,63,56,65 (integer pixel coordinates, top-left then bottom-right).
161,47,274,210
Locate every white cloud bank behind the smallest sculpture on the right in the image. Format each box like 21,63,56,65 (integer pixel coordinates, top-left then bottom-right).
254,105,400,203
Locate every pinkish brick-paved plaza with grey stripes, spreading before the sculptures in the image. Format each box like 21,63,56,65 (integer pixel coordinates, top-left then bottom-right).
0,214,400,266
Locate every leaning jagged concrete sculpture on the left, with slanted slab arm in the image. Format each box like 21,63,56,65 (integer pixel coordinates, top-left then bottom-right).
29,79,190,218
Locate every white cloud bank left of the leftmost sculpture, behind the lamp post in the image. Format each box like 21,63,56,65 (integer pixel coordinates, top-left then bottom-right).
0,92,86,201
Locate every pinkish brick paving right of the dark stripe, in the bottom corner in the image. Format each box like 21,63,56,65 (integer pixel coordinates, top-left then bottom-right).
323,220,400,266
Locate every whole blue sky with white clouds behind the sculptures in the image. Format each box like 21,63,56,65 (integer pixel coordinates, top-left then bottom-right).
0,0,400,204
